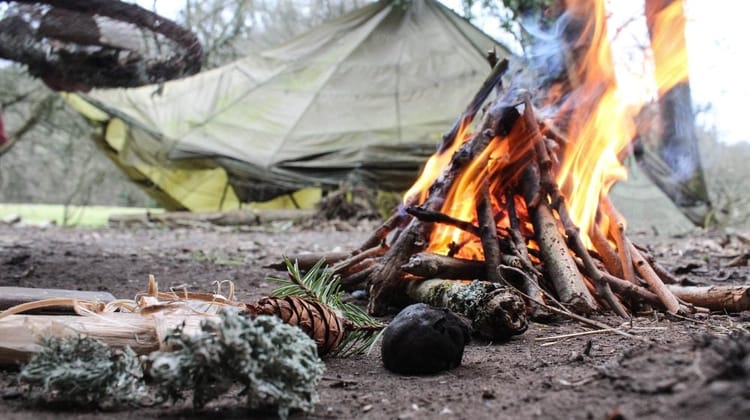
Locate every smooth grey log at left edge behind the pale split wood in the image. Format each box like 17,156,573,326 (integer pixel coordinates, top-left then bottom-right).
0,286,115,314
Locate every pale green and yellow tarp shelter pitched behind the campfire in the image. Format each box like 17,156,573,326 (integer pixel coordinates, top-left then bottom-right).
67,0,510,210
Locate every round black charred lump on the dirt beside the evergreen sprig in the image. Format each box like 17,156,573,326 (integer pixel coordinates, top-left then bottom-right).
381,303,471,375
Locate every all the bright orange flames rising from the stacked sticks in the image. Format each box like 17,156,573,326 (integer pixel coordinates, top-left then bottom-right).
405,0,688,259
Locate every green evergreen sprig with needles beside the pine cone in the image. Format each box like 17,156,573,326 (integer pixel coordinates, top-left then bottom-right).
269,257,385,357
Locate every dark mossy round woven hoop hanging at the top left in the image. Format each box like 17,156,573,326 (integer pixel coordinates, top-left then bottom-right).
0,0,203,91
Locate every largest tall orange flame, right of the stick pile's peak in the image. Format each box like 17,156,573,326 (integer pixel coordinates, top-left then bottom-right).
557,0,637,244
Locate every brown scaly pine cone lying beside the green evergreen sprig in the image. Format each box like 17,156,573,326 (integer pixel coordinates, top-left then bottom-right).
248,296,346,356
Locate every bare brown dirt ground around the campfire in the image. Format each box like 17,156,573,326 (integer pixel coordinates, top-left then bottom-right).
0,222,750,419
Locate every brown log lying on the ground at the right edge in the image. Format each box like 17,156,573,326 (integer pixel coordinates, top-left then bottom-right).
667,284,750,312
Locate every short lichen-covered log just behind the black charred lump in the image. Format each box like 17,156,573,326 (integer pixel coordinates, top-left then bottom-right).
406,279,528,341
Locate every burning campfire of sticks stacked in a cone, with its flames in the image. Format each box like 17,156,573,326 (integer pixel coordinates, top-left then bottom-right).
284,1,744,331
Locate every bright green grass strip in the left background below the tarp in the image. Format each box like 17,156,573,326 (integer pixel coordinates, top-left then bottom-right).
0,204,163,227
